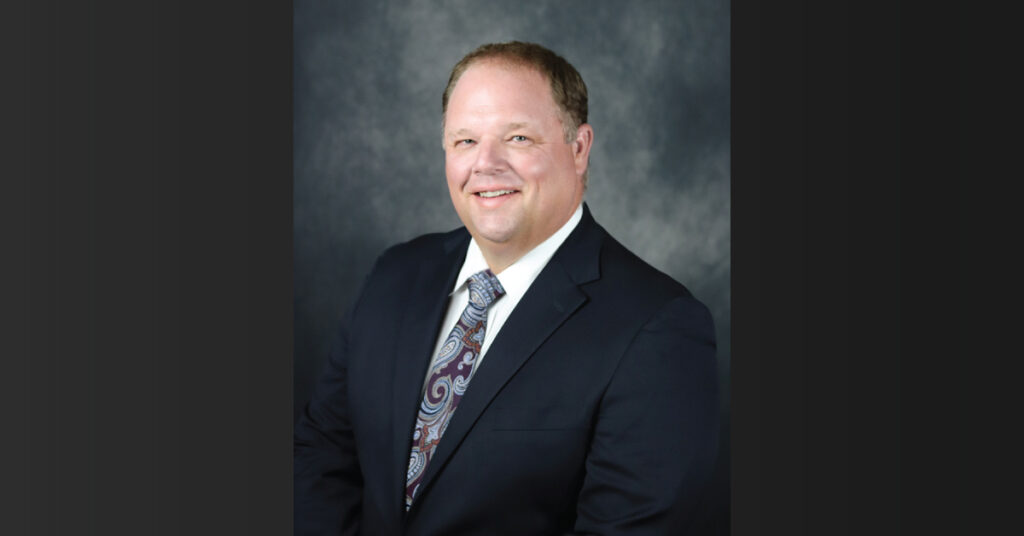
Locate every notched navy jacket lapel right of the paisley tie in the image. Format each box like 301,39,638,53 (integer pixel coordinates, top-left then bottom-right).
413,205,603,510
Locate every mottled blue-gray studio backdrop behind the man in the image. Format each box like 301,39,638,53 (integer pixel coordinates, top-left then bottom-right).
294,0,730,524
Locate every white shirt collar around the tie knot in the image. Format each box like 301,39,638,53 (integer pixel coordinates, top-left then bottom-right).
449,202,583,297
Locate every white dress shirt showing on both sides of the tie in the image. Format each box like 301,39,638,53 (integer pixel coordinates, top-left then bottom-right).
423,203,583,388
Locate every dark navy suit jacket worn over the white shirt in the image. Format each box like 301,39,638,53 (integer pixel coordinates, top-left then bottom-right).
295,206,718,536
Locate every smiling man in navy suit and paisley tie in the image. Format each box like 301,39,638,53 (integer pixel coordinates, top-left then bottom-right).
295,42,718,535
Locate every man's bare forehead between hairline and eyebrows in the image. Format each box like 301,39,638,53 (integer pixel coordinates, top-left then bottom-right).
447,60,557,121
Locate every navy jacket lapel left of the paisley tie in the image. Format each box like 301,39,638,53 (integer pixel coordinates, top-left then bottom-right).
391,233,469,516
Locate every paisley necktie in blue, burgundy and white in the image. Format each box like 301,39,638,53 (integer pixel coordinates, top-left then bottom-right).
406,270,505,510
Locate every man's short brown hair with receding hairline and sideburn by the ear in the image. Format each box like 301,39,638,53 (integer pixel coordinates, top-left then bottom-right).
441,41,587,143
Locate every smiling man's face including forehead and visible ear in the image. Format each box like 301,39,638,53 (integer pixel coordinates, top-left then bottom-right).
444,60,593,269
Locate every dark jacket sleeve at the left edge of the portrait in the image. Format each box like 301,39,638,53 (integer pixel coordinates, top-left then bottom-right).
293,272,372,536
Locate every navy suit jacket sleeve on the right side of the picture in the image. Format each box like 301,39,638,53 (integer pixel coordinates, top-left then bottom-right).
575,296,718,535
